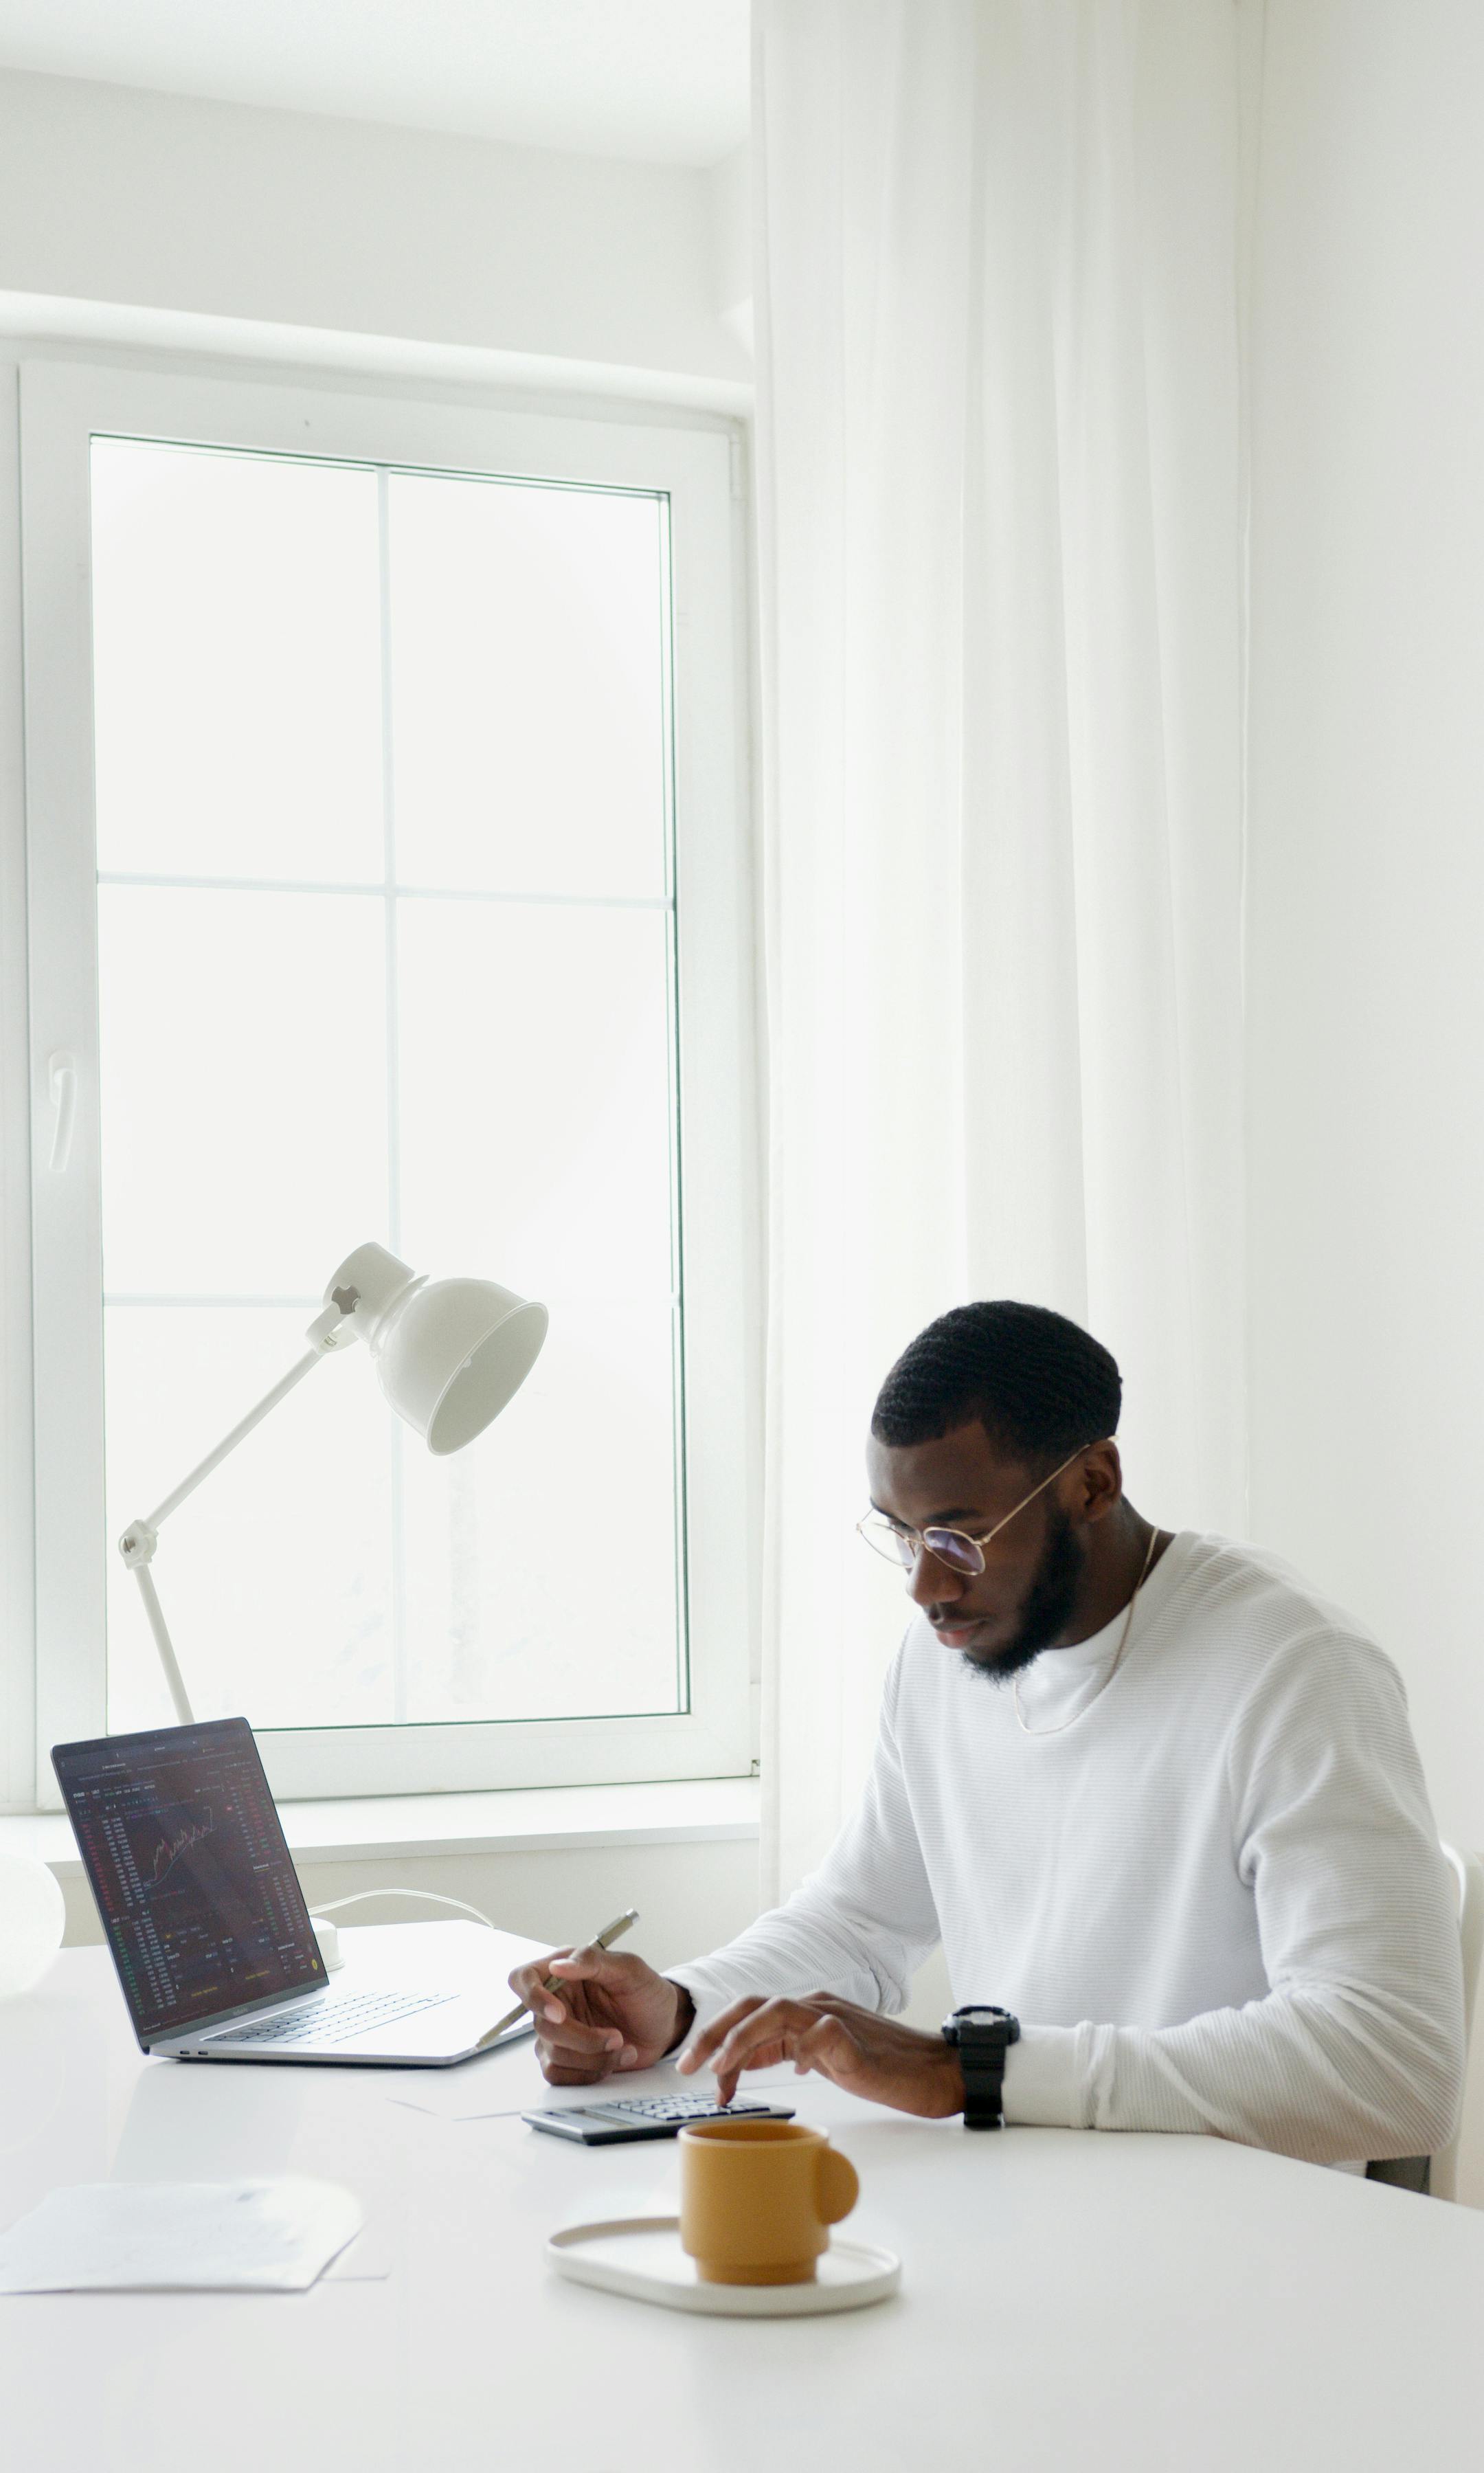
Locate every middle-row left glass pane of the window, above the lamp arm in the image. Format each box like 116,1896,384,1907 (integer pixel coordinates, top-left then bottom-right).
99,885,386,1296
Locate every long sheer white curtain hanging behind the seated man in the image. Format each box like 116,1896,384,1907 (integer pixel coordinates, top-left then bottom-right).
754,0,1244,1894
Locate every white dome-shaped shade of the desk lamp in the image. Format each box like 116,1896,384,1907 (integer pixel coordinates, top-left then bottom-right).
324,1244,547,1457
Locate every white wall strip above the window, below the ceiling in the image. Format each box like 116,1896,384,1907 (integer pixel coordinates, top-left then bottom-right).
0,71,752,388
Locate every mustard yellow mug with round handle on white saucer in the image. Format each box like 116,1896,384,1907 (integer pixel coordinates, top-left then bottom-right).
680,2122,861,2285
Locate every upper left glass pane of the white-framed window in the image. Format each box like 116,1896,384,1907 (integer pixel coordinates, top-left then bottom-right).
91,438,383,883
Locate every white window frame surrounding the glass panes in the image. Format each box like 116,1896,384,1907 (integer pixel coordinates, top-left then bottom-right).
10,359,759,1808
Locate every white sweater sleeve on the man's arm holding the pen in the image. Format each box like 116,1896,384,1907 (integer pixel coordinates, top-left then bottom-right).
668,1652,937,2026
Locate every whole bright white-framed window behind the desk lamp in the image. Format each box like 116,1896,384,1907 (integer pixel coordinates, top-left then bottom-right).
22,363,752,1793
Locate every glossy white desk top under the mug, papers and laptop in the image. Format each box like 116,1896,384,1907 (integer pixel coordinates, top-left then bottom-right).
0,1927,1484,2473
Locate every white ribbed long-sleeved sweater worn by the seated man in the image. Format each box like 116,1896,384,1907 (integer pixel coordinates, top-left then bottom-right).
671,1531,1464,2164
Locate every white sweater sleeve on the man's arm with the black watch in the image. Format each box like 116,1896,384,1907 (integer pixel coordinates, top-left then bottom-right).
1004,1630,1464,2164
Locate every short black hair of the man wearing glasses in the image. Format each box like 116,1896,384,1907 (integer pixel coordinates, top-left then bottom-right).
870,1298,1123,1462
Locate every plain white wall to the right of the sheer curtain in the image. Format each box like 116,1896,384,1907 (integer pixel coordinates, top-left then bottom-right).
1249,0,1484,2204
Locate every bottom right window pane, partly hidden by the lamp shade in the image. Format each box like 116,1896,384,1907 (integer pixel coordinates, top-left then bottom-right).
405,1301,683,1719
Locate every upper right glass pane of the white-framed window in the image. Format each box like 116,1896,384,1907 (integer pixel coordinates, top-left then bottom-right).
388,472,665,897
